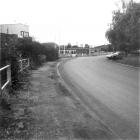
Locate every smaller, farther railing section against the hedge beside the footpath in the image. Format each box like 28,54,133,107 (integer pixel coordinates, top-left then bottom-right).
19,58,30,72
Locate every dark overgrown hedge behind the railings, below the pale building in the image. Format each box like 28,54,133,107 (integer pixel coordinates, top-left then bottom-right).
1,38,58,90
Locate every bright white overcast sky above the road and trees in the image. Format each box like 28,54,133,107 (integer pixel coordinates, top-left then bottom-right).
0,0,138,47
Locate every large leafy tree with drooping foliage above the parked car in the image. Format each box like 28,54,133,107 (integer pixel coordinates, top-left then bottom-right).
106,1,140,54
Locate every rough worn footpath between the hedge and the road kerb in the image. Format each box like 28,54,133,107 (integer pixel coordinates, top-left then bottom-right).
0,62,114,140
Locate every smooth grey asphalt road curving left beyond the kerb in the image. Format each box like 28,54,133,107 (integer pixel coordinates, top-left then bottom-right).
59,56,139,140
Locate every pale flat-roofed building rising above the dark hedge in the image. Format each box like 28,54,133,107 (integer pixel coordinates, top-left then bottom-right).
0,24,29,38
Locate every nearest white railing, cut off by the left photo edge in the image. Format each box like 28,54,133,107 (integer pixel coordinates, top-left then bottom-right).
0,65,11,93
